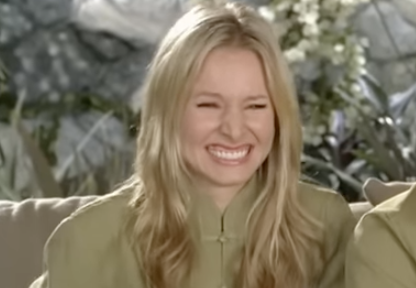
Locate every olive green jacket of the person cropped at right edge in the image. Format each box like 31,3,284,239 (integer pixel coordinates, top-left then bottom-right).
346,184,416,288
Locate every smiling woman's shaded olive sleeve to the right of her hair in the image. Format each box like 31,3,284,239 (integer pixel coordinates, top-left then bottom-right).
318,194,356,288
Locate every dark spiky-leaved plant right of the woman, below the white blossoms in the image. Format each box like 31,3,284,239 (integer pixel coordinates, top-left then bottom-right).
303,75,416,201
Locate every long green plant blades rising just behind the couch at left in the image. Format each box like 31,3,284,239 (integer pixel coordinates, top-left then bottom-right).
0,104,136,200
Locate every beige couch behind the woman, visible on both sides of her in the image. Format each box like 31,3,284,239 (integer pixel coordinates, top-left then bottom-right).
0,179,409,288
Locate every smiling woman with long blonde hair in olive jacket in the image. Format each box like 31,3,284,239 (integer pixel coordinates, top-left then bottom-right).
32,3,355,288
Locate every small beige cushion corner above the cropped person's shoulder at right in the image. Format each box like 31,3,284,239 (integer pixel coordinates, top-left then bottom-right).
363,178,414,206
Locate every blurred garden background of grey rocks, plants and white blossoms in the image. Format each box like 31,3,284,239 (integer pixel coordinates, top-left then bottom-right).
0,0,416,202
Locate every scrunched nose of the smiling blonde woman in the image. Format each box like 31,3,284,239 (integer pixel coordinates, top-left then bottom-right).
220,107,245,142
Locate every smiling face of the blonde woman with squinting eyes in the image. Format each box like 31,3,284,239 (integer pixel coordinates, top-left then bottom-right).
181,47,275,200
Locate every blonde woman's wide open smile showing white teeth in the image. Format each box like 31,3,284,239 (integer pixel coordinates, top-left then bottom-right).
207,145,252,165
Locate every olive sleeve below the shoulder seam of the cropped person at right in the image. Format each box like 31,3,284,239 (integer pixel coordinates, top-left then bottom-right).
346,212,416,288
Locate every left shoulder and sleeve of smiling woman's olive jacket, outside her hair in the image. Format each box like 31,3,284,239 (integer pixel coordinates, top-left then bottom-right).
31,188,141,288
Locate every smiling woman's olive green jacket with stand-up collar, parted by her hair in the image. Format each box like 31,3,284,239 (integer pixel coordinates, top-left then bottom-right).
31,184,356,288
